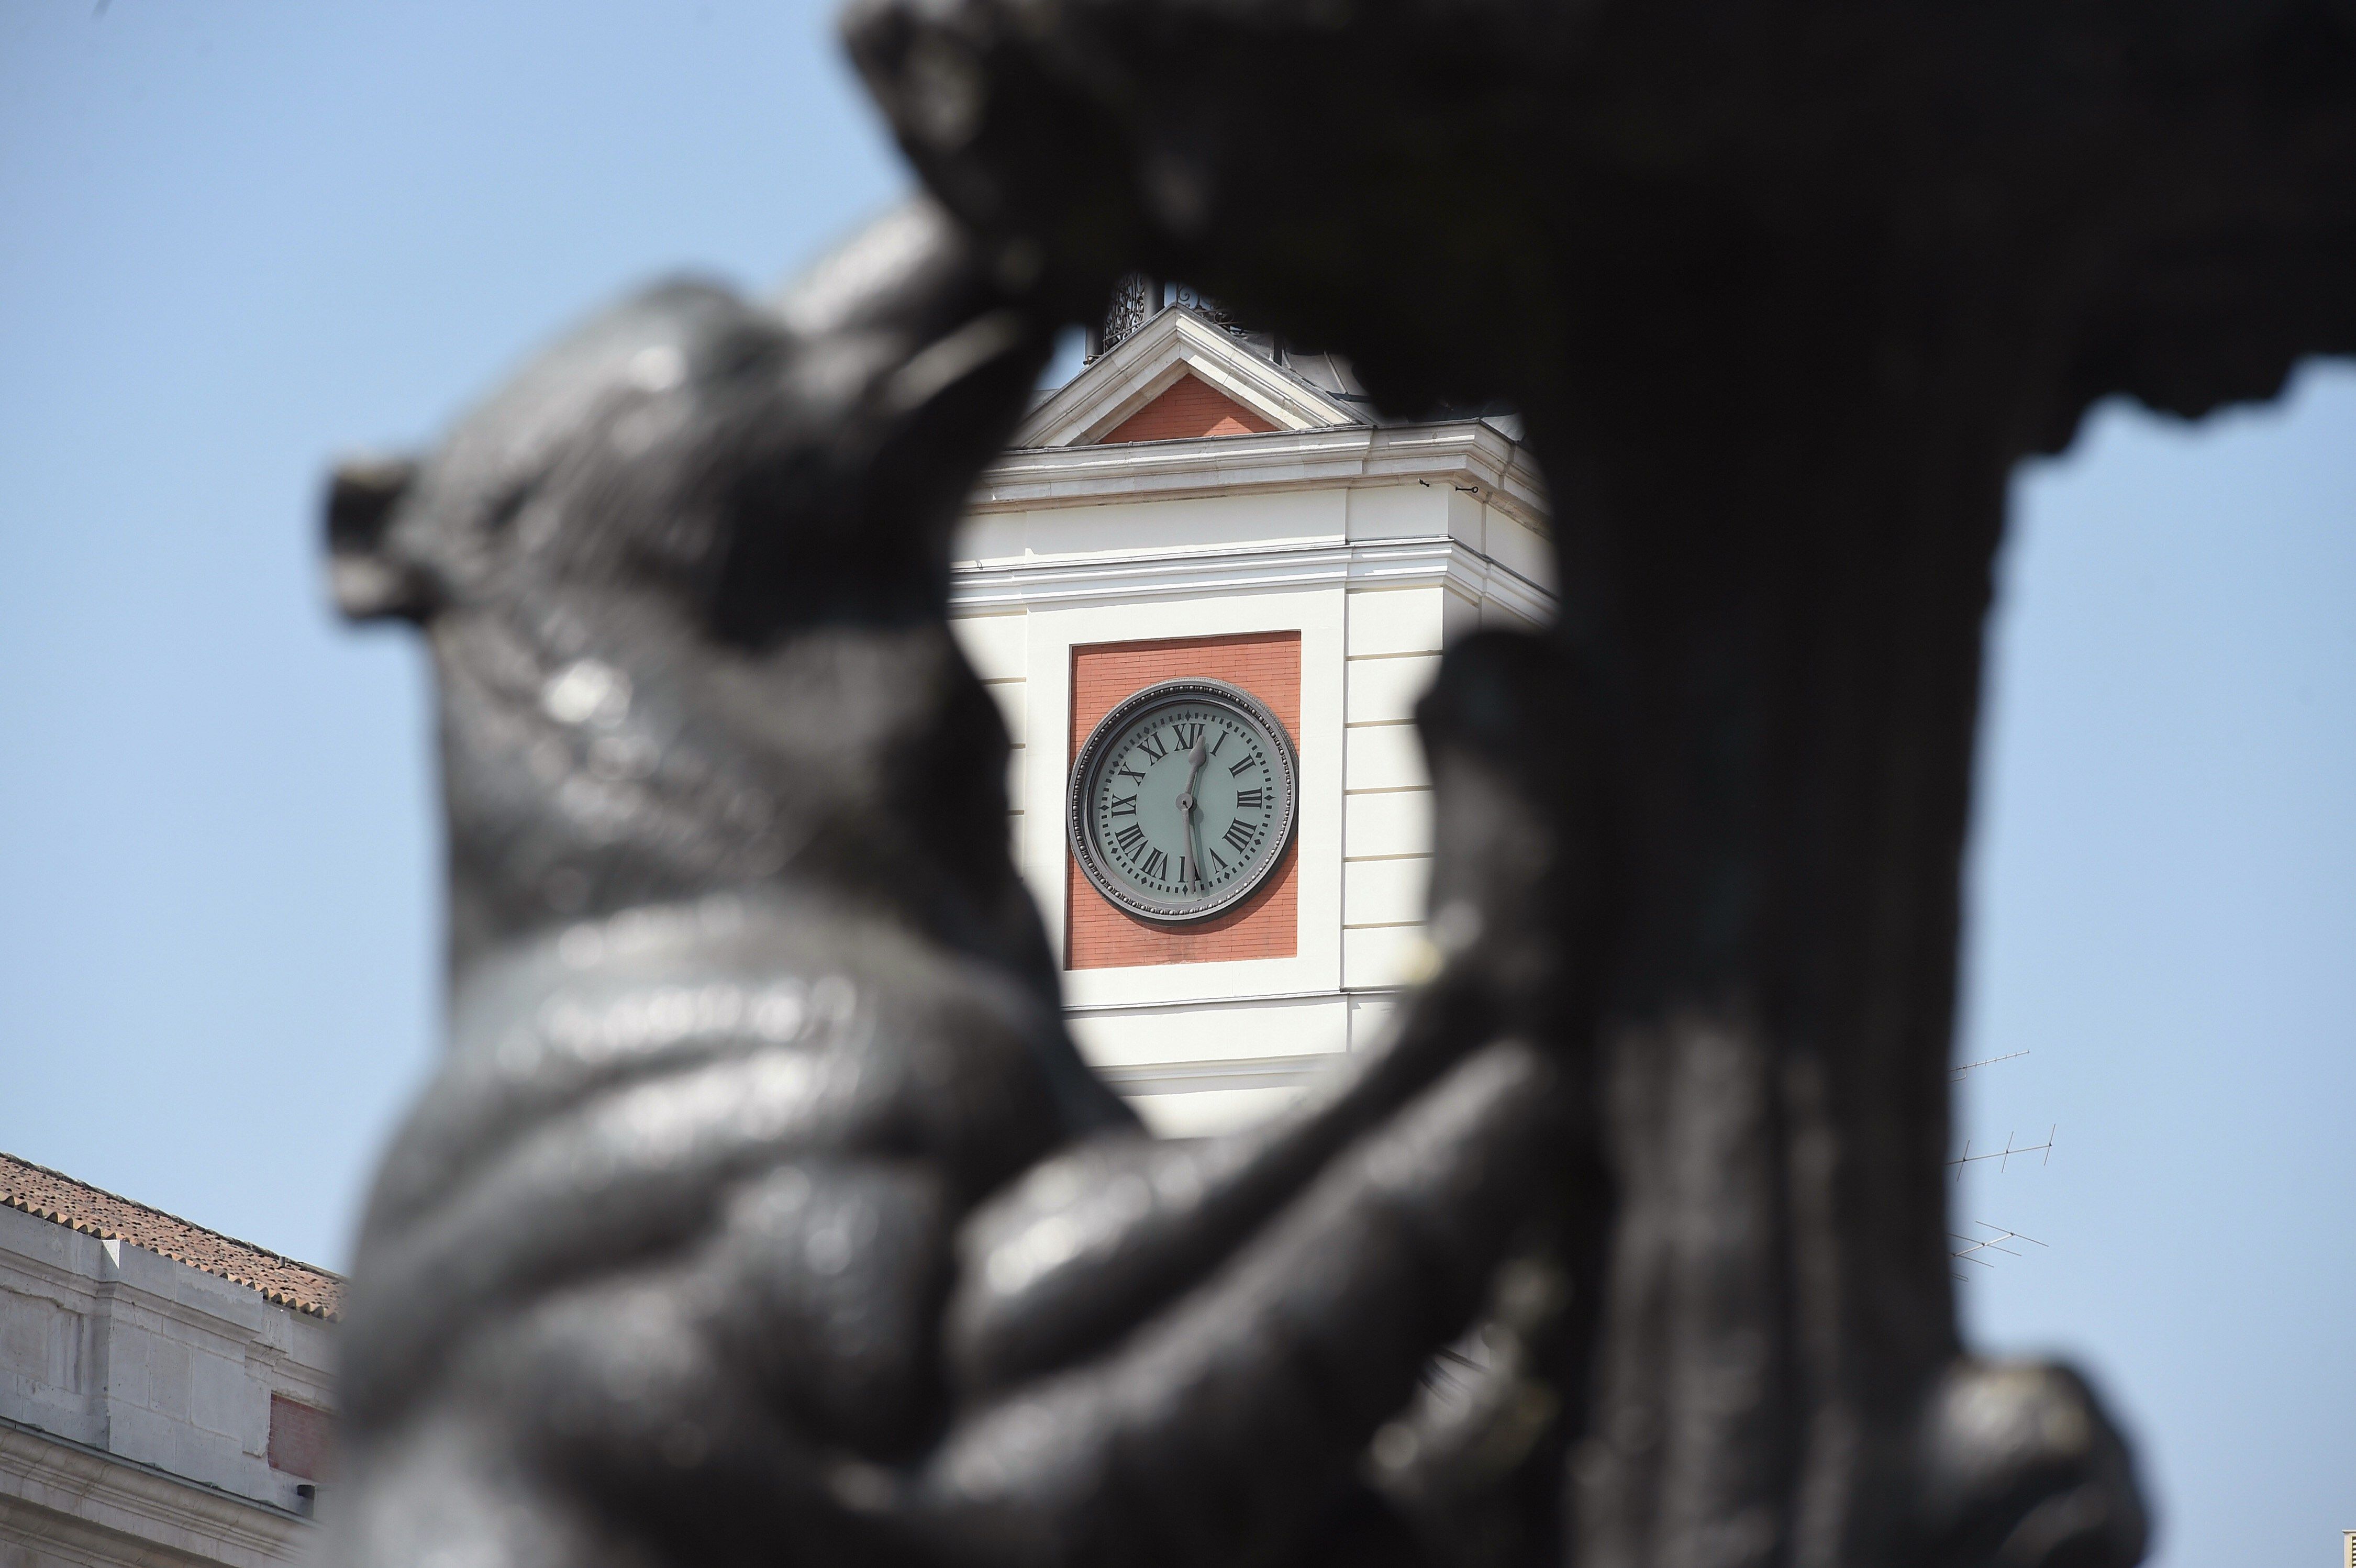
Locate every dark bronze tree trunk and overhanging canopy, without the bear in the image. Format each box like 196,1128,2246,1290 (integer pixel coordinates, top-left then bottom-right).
851,0,2356,1568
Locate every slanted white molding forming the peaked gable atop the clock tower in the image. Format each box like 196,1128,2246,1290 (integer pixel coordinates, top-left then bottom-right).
1016,306,1364,452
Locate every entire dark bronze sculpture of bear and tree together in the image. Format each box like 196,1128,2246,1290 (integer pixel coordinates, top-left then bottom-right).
330,0,2356,1568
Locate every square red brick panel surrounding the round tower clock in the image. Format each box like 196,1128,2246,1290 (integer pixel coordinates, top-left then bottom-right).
1063,631,1301,970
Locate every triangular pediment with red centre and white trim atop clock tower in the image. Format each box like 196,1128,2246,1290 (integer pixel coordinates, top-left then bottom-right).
1016,306,1366,447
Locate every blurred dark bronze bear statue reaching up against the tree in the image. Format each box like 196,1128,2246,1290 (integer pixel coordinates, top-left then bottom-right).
328,203,1595,1568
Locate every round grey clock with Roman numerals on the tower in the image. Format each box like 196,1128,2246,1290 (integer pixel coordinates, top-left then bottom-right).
1070,681,1298,920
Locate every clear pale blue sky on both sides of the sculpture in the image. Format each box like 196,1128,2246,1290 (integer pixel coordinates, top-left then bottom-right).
0,0,2356,1568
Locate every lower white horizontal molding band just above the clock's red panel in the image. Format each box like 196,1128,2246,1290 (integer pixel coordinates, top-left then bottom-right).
950,535,1558,621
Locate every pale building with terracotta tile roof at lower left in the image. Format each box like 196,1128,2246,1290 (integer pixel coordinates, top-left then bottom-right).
0,1154,342,1568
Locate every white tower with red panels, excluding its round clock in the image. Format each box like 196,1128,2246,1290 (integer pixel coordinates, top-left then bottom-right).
952,287,1555,1135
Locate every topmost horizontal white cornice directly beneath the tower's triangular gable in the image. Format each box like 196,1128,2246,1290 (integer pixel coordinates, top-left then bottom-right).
966,419,1546,532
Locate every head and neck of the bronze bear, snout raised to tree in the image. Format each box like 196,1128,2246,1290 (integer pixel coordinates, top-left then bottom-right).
328,207,1046,988
